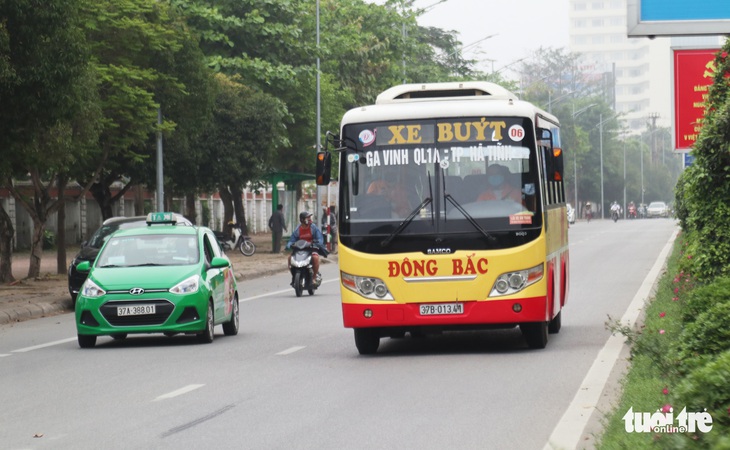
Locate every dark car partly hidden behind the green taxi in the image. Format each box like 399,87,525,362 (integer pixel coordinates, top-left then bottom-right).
68,213,193,304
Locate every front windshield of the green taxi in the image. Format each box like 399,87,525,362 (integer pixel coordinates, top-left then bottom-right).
95,234,200,268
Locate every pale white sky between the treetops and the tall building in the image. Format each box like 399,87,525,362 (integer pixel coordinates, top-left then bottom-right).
414,0,568,79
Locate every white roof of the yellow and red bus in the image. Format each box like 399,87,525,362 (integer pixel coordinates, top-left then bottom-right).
342,81,558,126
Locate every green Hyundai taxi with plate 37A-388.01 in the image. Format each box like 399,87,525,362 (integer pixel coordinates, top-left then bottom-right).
76,213,239,348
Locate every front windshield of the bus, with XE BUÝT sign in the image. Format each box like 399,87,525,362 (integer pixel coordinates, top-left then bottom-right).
340,117,542,251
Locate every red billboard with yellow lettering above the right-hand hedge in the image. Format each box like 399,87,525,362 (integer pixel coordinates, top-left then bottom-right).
672,48,719,151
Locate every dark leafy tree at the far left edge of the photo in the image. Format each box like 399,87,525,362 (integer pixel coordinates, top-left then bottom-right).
0,0,94,281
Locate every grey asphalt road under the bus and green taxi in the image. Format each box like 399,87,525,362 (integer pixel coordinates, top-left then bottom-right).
0,219,676,449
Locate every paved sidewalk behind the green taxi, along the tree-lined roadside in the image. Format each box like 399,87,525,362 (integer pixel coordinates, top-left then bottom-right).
0,234,337,325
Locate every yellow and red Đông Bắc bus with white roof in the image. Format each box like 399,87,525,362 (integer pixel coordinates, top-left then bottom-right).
317,82,569,354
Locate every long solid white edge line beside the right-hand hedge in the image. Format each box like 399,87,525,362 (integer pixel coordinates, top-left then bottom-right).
543,230,678,450
